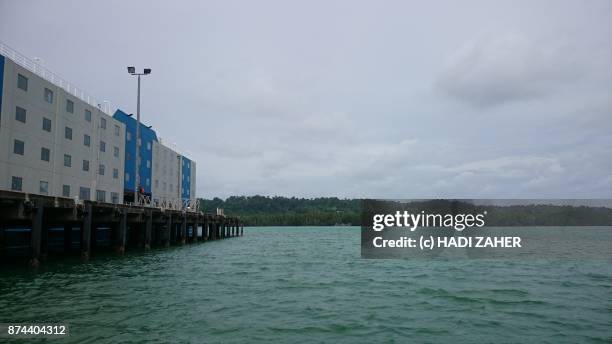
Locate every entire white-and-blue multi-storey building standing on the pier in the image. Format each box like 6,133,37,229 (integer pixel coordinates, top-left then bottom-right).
0,43,196,208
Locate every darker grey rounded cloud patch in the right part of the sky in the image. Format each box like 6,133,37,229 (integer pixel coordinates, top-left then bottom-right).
434,34,587,107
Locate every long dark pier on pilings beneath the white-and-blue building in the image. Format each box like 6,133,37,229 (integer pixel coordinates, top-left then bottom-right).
0,191,244,267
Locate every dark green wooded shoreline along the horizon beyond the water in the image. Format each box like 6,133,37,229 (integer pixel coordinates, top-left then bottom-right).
200,195,612,226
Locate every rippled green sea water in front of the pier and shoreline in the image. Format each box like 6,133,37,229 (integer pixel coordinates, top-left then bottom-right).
0,227,612,343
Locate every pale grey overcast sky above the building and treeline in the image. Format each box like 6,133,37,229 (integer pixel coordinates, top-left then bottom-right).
0,0,612,198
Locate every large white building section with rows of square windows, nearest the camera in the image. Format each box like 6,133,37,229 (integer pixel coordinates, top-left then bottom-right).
0,50,125,203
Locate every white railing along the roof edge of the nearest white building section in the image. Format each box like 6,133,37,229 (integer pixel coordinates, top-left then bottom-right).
0,42,111,115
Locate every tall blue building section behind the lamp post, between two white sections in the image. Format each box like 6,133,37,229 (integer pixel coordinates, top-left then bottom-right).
113,110,157,196
